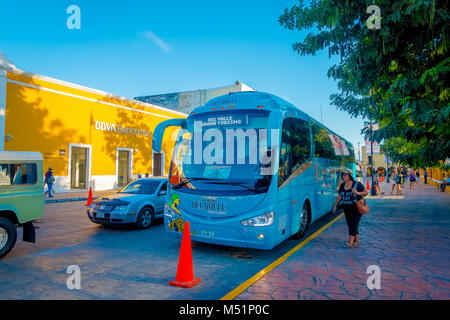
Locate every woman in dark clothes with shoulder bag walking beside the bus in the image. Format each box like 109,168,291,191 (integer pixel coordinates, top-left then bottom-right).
333,169,368,247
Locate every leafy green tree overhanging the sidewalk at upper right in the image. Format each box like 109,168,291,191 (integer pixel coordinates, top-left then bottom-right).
279,0,450,167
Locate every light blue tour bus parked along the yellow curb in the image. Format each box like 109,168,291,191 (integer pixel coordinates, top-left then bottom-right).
153,92,356,249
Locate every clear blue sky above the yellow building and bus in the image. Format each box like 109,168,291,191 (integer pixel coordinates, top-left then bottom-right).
0,0,364,155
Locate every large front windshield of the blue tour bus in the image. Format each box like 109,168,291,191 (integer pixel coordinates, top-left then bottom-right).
169,110,272,195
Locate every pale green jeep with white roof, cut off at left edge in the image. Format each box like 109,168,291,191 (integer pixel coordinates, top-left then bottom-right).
0,151,44,258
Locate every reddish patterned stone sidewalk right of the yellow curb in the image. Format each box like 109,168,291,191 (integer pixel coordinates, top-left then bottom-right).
236,182,450,300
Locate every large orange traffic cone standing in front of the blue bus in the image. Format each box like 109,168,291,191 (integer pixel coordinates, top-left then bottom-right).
169,221,200,288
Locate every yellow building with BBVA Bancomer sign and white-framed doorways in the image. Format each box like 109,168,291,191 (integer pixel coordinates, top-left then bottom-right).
0,52,187,192
